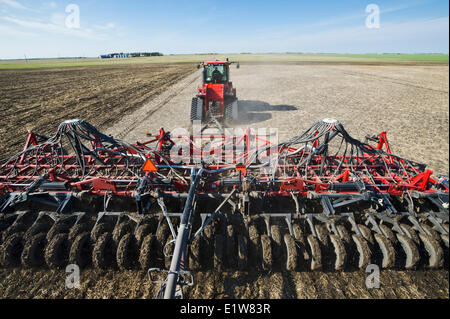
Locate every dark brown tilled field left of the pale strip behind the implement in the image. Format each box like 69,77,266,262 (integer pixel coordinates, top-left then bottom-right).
0,64,195,159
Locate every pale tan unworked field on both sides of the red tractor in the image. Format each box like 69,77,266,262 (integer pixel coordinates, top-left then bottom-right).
108,64,449,175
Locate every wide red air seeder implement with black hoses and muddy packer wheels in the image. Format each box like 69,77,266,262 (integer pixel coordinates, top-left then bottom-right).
0,119,449,298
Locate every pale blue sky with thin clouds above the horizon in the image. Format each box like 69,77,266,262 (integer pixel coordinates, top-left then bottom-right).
0,0,449,59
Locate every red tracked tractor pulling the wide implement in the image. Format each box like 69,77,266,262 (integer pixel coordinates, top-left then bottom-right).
191,59,239,124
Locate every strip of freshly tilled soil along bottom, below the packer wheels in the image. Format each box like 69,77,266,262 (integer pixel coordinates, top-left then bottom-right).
0,269,449,299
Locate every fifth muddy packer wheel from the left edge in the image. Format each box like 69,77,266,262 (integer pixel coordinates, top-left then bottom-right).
92,233,117,270
